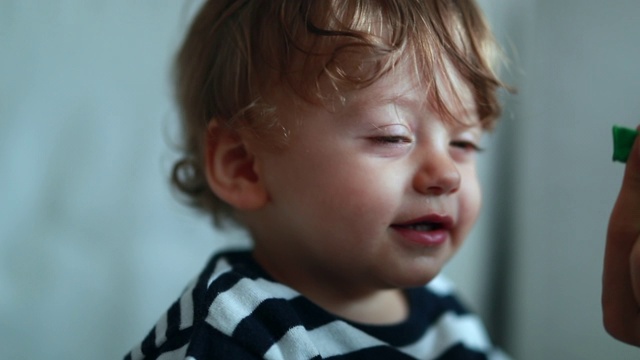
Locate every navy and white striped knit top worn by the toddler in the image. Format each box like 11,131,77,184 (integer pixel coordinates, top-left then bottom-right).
125,251,506,360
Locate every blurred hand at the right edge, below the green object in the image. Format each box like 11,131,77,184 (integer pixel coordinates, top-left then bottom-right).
602,127,640,346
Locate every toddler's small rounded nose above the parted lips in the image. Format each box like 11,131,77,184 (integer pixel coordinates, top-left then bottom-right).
414,151,461,195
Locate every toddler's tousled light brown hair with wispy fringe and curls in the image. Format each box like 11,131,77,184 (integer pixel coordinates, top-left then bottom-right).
172,0,504,225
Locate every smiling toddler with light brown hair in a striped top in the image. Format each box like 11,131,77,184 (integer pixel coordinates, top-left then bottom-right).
127,0,503,360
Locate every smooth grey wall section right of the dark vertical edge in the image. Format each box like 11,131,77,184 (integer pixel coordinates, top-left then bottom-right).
502,0,640,359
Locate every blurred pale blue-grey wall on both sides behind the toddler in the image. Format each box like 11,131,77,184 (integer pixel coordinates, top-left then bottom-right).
0,0,640,360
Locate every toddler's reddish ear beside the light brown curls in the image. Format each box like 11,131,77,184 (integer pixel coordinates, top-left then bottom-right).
205,122,268,210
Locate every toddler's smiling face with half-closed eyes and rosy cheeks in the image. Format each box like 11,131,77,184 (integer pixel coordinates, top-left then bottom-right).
248,62,483,291
